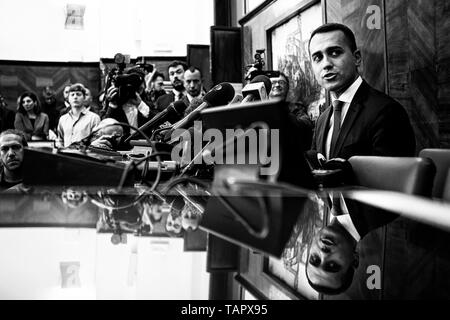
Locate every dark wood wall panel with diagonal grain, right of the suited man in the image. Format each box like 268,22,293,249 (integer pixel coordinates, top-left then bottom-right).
386,0,440,151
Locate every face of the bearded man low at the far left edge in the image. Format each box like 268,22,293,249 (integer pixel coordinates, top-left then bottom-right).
0,134,23,171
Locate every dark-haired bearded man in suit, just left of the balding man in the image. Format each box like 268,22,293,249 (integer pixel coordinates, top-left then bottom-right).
155,60,189,112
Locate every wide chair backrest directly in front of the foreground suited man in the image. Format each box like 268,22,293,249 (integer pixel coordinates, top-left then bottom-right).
349,156,436,196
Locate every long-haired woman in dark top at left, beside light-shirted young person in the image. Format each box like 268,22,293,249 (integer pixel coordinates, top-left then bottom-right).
14,92,50,141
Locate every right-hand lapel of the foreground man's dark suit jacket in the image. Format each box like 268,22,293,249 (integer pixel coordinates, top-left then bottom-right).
330,81,369,158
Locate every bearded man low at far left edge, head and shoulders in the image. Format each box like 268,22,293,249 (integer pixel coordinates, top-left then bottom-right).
0,129,28,191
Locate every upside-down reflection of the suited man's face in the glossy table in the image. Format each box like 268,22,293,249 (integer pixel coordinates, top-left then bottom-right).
306,224,358,289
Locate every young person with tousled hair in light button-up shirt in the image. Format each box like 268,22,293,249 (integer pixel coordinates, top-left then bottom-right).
58,83,100,147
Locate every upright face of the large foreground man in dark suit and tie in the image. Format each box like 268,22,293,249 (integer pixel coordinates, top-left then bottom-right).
310,30,361,95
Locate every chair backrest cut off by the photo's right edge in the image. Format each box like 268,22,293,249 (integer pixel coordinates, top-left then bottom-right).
419,149,450,198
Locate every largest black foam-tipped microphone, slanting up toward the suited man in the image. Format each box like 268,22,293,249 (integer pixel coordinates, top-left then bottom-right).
172,82,234,132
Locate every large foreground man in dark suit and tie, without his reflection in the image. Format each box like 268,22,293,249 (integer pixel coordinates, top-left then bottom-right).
309,24,415,159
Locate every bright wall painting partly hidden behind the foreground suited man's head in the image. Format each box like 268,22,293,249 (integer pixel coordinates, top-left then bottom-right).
267,1,326,120
